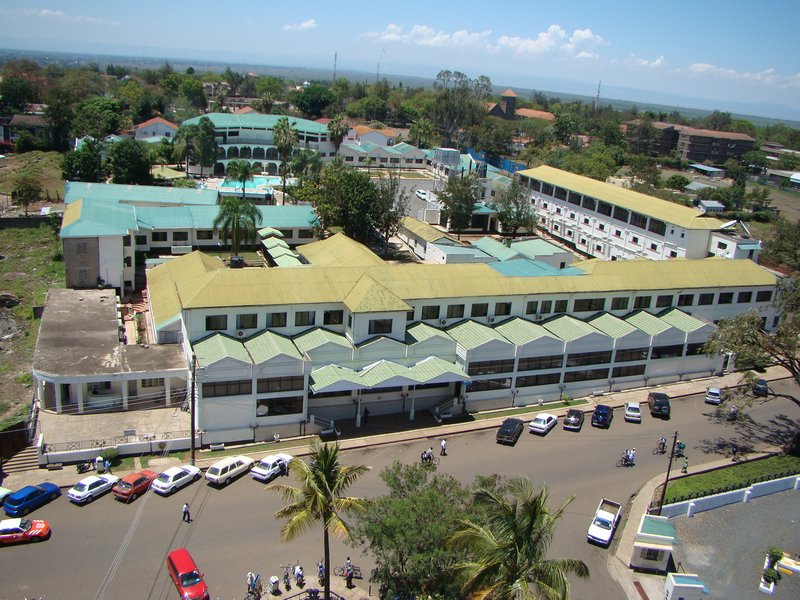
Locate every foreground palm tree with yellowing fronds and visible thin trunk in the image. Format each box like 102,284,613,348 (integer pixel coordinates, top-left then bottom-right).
267,442,370,600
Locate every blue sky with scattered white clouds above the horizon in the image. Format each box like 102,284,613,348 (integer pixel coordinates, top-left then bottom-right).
0,0,800,118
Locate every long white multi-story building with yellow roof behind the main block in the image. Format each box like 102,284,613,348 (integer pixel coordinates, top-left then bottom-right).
519,166,760,260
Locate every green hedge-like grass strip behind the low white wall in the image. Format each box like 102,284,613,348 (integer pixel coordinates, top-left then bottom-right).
664,455,800,504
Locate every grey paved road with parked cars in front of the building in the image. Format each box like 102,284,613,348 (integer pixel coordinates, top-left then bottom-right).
0,382,800,600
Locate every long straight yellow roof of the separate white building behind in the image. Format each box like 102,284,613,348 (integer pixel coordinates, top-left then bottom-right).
520,165,724,229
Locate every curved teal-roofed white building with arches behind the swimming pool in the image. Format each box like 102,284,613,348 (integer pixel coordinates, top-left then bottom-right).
183,113,336,176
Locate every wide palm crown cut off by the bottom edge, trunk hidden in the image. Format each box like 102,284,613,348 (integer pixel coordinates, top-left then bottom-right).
449,477,589,600
